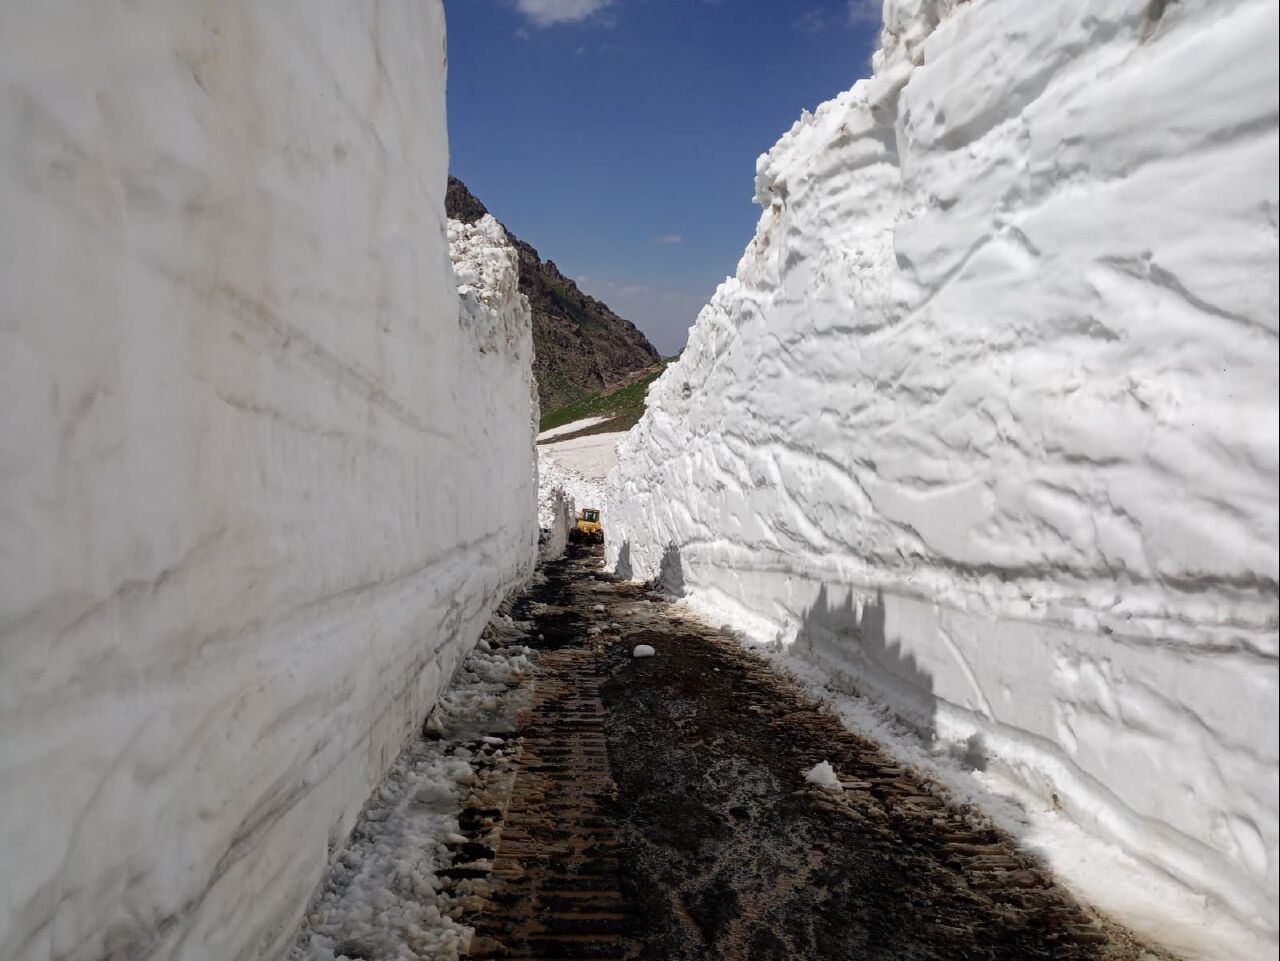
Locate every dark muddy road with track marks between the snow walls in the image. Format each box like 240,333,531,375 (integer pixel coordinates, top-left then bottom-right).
460,546,1166,961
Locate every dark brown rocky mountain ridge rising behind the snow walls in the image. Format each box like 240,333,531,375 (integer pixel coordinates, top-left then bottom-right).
444,177,659,413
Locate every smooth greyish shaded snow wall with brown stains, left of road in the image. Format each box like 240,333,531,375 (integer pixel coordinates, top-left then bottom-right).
0,7,536,961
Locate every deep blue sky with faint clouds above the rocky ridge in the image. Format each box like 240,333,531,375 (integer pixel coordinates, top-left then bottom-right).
445,0,879,354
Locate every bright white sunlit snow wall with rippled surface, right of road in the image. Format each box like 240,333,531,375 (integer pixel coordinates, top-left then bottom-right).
607,0,1277,956
